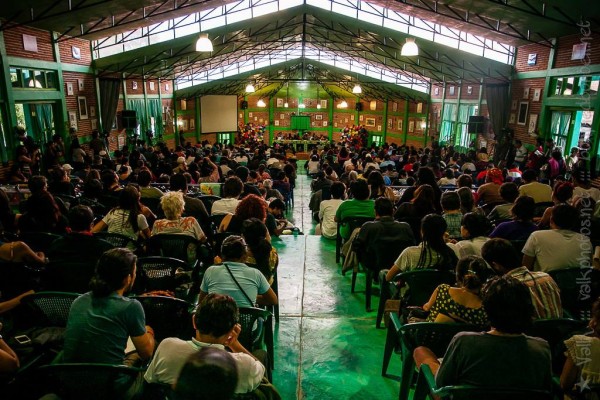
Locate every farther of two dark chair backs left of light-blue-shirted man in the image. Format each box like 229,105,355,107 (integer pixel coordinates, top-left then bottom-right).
136,256,187,292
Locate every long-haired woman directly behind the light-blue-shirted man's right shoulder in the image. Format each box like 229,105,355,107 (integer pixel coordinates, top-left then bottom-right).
242,218,279,284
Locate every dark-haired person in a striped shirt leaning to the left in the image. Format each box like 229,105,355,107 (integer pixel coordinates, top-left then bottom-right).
481,238,562,319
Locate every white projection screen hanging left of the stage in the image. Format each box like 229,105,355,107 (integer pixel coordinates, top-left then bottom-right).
200,96,237,133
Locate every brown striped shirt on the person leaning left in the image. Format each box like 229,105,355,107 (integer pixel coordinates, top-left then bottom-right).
506,267,562,319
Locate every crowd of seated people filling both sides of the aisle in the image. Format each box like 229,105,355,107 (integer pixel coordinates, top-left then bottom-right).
0,133,600,398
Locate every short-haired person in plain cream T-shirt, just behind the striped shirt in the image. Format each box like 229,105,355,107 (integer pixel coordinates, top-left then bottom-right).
523,204,592,272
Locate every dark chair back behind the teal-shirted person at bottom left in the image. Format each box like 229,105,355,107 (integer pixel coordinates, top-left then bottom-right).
32,363,143,400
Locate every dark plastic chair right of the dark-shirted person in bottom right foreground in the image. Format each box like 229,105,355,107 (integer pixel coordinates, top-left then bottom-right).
526,318,589,376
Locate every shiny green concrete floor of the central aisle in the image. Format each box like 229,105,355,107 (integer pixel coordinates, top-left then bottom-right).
273,175,400,400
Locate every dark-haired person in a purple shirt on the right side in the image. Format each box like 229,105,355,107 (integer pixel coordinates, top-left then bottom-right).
490,196,537,240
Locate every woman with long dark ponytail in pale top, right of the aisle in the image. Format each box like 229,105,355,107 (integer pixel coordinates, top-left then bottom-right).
385,214,458,282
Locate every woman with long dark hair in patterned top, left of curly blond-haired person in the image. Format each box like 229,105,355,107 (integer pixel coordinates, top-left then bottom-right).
92,185,150,241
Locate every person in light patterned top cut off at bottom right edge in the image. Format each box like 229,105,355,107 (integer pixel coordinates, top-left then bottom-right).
560,299,600,392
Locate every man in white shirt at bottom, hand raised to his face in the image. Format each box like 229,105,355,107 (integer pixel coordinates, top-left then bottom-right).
144,293,265,393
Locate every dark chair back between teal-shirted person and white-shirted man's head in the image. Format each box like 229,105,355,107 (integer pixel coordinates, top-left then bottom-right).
133,296,194,342
